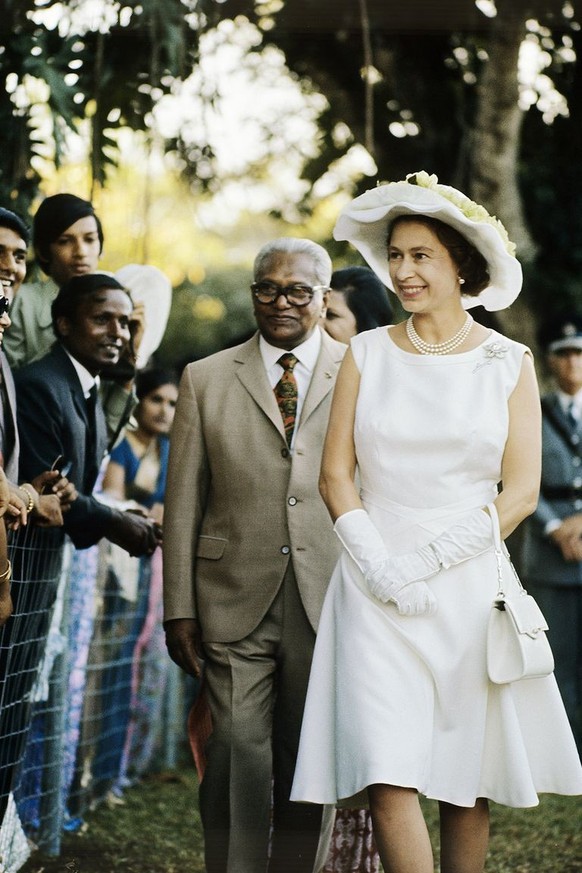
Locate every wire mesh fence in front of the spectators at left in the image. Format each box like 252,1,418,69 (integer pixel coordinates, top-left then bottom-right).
0,526,190,873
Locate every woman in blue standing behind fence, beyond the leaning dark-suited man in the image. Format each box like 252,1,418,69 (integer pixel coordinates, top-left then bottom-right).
96,367,178,794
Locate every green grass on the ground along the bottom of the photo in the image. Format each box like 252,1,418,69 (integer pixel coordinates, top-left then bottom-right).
21,770,582,873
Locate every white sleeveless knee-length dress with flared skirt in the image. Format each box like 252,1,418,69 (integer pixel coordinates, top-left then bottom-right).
291,327,582,807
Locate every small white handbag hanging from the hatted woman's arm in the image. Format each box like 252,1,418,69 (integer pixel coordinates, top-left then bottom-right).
487,504,554,684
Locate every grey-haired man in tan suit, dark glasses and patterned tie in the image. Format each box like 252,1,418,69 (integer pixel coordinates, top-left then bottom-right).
164,238,346,873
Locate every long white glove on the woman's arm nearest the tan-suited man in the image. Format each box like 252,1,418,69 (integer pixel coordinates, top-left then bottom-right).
334,509,440,615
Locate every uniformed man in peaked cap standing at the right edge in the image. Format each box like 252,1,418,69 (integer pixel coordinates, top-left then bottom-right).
523,315,582,751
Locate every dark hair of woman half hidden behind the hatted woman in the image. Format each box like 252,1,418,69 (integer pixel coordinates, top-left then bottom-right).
330,267,394,333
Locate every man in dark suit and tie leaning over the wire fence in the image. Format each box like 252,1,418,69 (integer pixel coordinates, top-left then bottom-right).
15,273,161,555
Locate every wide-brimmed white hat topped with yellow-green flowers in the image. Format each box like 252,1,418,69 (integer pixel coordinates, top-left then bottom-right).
333,171,523,310
